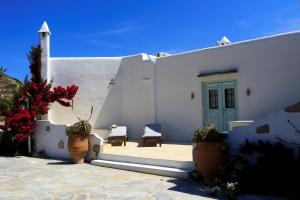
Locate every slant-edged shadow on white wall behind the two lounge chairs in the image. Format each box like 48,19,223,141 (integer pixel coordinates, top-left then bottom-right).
93,55,155,139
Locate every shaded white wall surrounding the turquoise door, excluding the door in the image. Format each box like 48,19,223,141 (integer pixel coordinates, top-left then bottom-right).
155,33,300,141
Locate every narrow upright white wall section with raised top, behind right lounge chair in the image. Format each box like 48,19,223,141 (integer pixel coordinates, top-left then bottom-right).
117,55,155,139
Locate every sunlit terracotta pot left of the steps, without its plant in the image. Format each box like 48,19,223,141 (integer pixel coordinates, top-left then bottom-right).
68,135,89,164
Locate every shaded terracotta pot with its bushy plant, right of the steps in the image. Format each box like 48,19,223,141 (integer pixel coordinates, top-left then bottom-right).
193,124,227,184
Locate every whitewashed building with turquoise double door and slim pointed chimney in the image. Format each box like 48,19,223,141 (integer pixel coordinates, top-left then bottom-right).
39,23,300,152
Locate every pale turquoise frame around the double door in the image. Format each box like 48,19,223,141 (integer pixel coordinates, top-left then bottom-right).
201,77,239,133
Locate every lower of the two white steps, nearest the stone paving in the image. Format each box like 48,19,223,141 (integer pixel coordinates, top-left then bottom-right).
91,160,189,179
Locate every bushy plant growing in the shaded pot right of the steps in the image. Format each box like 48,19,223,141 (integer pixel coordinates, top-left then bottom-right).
193,124,227,143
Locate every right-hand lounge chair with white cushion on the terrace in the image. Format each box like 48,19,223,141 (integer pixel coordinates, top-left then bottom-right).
143,124,162,146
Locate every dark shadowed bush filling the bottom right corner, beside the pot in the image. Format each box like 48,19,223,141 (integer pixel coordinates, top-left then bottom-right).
214,141,300,199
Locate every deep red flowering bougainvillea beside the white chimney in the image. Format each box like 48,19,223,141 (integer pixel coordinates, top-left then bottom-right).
0,80,78,142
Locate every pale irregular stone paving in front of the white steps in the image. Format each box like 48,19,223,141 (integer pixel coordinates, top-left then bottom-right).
0,156,286,200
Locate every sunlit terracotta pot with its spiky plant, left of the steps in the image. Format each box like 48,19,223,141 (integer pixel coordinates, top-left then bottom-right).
66,101,93,164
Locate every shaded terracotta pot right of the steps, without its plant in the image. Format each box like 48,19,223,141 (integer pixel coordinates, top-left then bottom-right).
195,142,224,185
